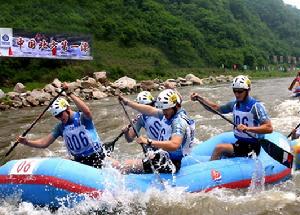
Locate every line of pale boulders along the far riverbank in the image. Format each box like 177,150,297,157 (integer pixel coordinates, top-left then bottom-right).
0,71,233,111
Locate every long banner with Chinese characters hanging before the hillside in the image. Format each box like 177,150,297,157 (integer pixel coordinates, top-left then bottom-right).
0,28,93,60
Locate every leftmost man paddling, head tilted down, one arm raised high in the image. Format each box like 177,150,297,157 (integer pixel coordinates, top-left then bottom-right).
17,83,116,168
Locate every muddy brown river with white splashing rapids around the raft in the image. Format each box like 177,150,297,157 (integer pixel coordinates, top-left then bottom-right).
0,78,300,215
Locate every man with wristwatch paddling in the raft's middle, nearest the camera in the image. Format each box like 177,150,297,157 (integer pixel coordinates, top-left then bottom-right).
119,89,195,173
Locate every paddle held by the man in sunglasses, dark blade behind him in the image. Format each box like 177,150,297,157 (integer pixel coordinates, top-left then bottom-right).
196,96,293,168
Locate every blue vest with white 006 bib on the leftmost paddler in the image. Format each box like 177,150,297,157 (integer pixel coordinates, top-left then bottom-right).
63,112,102,157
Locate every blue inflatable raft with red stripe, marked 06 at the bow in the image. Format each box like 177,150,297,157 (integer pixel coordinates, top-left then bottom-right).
0,132,291,207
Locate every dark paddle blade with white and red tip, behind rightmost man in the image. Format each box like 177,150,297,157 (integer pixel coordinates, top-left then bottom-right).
259,139,294,168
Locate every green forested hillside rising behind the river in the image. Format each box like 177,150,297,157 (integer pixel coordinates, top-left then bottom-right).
0,0,300,86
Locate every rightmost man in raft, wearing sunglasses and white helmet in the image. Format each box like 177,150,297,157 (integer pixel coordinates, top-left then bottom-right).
191,75,273,160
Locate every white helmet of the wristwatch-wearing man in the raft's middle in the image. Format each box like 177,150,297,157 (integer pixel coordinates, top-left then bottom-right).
155,89,181,110
